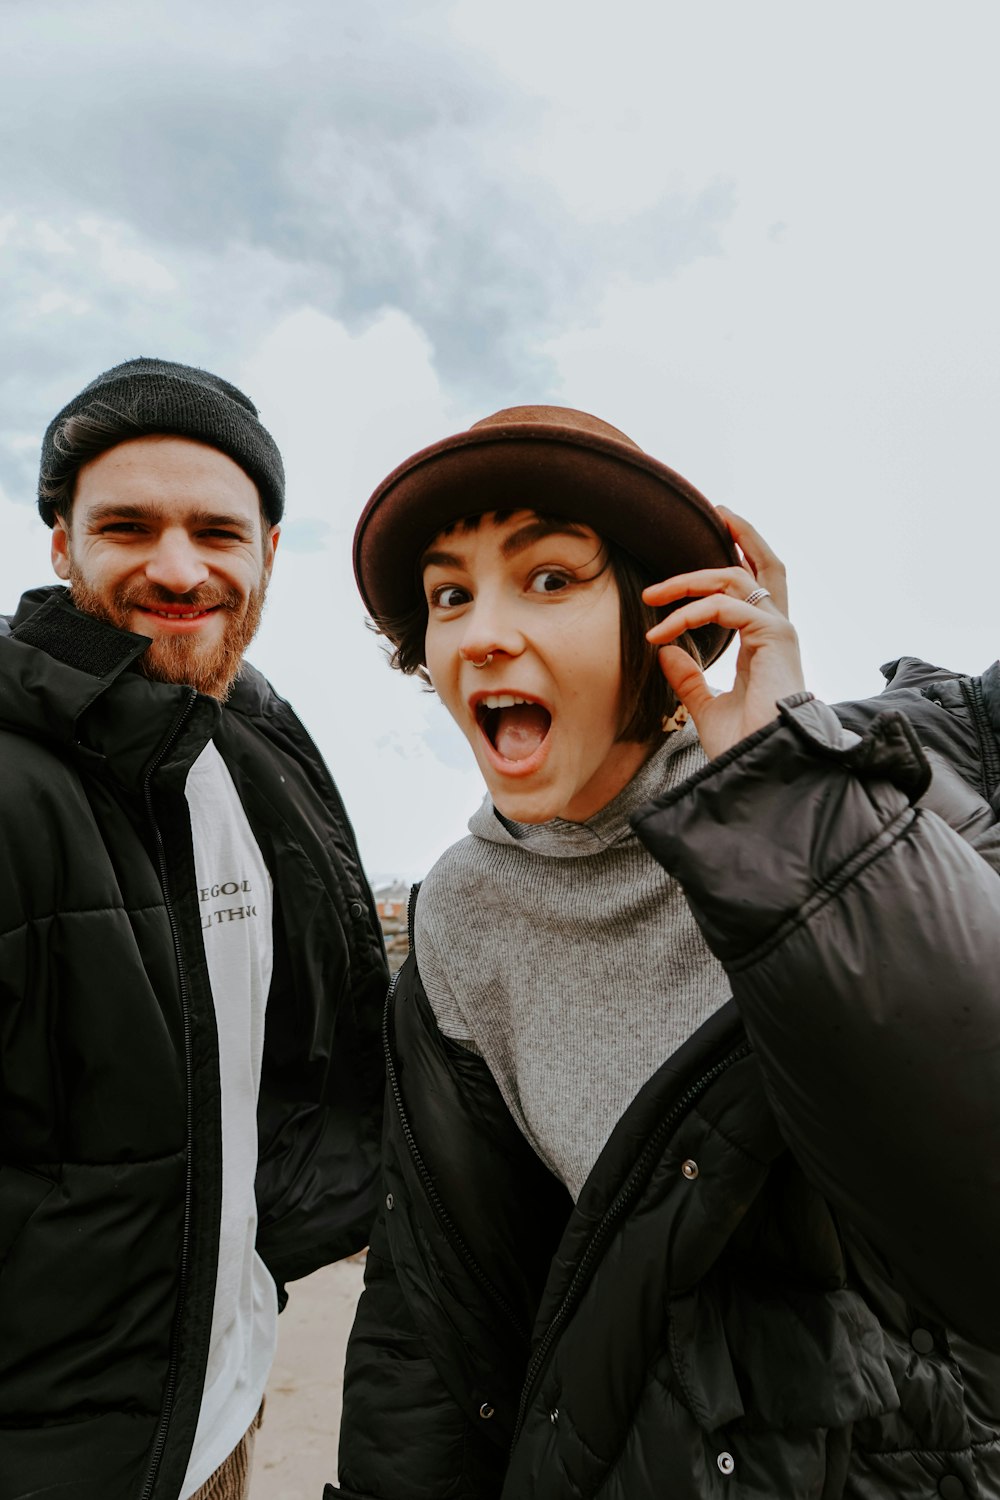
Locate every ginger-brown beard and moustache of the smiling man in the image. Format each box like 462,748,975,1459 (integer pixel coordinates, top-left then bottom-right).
69,560,267,702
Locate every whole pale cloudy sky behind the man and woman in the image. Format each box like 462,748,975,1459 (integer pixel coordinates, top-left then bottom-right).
0,0,1000,878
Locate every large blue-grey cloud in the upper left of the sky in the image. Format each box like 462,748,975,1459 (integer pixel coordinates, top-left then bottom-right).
0,0,732,405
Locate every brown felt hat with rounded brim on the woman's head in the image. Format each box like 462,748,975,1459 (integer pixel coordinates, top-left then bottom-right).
354,407,739,665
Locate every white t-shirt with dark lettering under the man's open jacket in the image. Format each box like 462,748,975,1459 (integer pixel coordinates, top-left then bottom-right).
180,741,277,1497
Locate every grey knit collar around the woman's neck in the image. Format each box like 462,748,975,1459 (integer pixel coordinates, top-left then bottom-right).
469,723,705,860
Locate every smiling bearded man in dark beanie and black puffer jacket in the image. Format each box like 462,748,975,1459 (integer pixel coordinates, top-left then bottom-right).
0,359,385,1500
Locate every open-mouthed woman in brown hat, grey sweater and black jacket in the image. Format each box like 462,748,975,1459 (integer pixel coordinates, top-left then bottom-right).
327,408,1000,1500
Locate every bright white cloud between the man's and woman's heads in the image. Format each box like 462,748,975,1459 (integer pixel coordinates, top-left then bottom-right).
238,298,481,878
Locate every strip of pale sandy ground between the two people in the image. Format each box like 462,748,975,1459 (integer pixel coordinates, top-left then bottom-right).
250,1256,364,1500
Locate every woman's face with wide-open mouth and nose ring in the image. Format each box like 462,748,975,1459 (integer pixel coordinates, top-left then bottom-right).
423,510,649,824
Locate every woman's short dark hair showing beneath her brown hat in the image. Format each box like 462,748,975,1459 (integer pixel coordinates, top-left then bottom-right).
372,512,702,744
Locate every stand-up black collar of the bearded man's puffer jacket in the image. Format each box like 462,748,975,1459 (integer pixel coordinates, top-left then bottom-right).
0,587,220,788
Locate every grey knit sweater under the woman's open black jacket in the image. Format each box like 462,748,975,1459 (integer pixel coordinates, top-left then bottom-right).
414,725,730,1199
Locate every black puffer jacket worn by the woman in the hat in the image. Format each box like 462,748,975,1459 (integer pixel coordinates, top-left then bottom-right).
327,669,1000,1500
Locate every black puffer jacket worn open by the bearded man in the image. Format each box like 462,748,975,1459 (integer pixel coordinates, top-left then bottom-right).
0,590,385,1500
